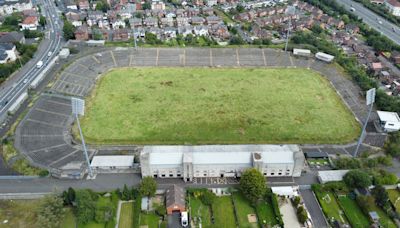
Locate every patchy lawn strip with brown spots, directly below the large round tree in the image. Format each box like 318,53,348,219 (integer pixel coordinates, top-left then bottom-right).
233,193,258,228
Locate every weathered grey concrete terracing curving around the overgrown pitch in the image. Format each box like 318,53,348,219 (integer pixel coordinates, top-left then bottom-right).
16,48,384,177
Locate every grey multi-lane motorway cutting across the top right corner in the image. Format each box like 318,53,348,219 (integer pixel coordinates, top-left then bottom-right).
338,0,400,45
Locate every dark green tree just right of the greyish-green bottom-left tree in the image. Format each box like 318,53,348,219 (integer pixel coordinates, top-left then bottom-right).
75,190,96,224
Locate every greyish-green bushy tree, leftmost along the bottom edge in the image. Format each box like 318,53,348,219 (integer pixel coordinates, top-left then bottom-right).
37,196,65,228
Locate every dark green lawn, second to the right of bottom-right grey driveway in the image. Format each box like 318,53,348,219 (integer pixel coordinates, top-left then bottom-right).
338,196,370,228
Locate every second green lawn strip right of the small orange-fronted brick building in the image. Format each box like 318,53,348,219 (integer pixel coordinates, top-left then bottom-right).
212,196,236,228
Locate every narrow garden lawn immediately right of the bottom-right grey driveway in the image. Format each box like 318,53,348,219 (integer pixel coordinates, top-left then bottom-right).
315,191,348,224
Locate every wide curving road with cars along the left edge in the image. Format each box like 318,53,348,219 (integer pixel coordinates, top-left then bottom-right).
0,0,62,125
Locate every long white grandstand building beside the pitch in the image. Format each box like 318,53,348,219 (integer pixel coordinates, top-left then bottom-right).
140,145,305,181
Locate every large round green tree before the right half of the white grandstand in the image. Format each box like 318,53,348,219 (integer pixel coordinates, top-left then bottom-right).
240,168,267,203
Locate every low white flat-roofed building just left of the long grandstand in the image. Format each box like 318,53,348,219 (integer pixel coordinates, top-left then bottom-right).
90,155,134,173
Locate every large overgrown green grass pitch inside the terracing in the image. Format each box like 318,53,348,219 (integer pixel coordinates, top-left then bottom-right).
81,68,360,144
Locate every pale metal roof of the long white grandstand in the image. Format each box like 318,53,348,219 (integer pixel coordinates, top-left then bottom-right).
143,145,300,165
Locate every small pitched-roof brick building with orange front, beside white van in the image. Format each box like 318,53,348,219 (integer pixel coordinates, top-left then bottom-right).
165,185,186,215
